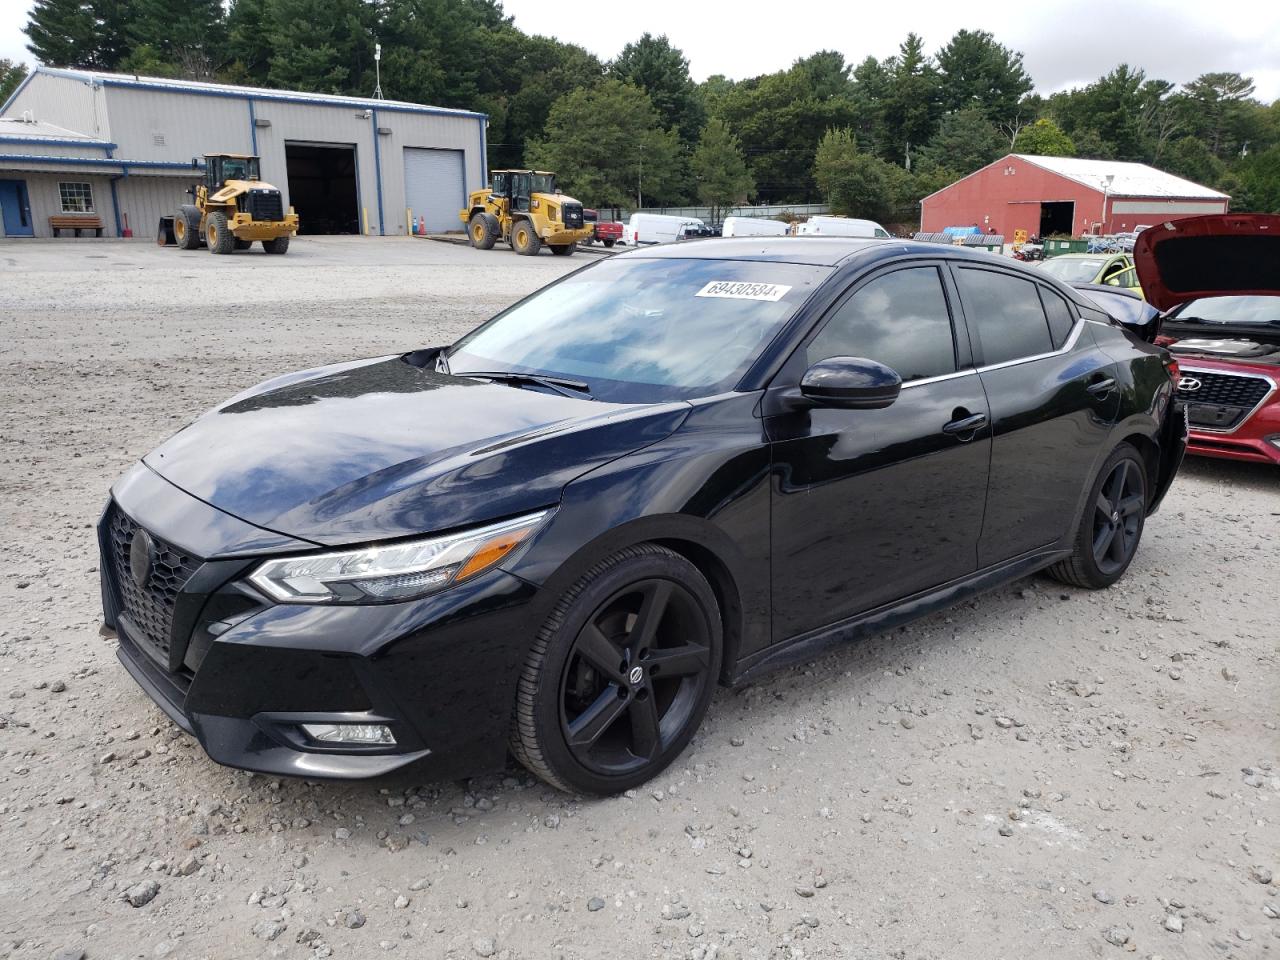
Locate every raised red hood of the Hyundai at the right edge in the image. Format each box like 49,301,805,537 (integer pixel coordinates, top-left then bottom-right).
1133,214,1280,310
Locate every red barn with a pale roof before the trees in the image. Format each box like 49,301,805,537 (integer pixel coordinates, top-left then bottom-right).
920,154,1230,239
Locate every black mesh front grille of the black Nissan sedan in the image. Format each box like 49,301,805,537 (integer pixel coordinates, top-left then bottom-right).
109,504,200,668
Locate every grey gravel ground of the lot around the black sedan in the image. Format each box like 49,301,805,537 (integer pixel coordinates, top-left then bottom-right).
0,239,1280,960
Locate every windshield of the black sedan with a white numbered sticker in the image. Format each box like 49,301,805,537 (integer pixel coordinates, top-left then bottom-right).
448,257,831,403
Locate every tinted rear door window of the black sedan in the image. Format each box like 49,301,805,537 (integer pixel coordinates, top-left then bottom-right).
956,268,1053,365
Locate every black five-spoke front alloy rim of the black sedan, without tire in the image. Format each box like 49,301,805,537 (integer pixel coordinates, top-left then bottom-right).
561,580,712,777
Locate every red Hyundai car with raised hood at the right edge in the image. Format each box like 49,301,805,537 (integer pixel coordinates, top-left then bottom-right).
1134,214,1280,465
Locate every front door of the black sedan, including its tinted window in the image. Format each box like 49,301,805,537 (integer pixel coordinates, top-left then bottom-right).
765,261,991,641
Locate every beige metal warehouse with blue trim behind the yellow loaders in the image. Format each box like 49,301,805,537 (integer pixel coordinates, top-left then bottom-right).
0,67,486,239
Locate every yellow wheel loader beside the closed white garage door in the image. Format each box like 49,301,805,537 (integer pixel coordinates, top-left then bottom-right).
458,170,593,256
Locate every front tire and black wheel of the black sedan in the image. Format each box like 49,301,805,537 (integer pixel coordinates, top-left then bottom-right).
509,544,723,795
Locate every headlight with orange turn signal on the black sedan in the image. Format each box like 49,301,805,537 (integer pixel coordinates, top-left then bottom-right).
250,509,550,603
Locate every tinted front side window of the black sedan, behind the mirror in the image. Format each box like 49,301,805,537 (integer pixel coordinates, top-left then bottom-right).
805,266,956,383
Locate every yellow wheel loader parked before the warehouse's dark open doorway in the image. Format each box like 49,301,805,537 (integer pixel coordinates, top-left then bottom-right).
157,154,298,253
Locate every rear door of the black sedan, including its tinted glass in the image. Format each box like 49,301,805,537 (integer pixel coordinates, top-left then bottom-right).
952,264,1120,567
